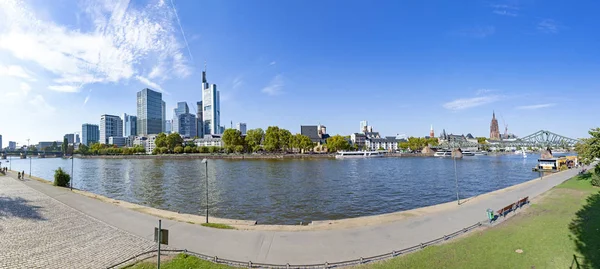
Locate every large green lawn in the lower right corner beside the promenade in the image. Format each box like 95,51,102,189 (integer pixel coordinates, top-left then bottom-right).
358,172,600,269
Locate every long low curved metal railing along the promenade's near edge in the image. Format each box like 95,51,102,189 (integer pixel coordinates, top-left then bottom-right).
108,222,484,269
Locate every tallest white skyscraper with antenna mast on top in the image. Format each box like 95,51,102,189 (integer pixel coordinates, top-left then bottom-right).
202,68,221,134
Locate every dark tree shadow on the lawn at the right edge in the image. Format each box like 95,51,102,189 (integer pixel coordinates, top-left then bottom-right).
569,192,600,268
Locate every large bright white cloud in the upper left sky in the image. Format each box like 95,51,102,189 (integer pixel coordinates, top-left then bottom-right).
0,0,191,92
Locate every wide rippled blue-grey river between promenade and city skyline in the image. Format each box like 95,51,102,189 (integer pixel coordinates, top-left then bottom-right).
2,154,552,224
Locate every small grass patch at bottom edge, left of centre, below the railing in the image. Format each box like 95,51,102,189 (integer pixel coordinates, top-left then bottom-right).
125,253,234,269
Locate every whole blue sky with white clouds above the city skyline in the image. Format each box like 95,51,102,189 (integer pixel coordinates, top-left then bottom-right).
0,0,600,146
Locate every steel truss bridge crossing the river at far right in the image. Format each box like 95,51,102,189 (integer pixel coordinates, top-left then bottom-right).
438,130,579,149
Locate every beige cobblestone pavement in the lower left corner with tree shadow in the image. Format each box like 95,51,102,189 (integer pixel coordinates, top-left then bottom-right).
0,176,155,269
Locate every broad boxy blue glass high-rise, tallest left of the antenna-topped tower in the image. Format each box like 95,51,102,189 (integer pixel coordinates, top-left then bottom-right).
137,88,165,135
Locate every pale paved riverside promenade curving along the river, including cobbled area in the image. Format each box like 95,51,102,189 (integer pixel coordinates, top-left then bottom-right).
0,165,592,267
